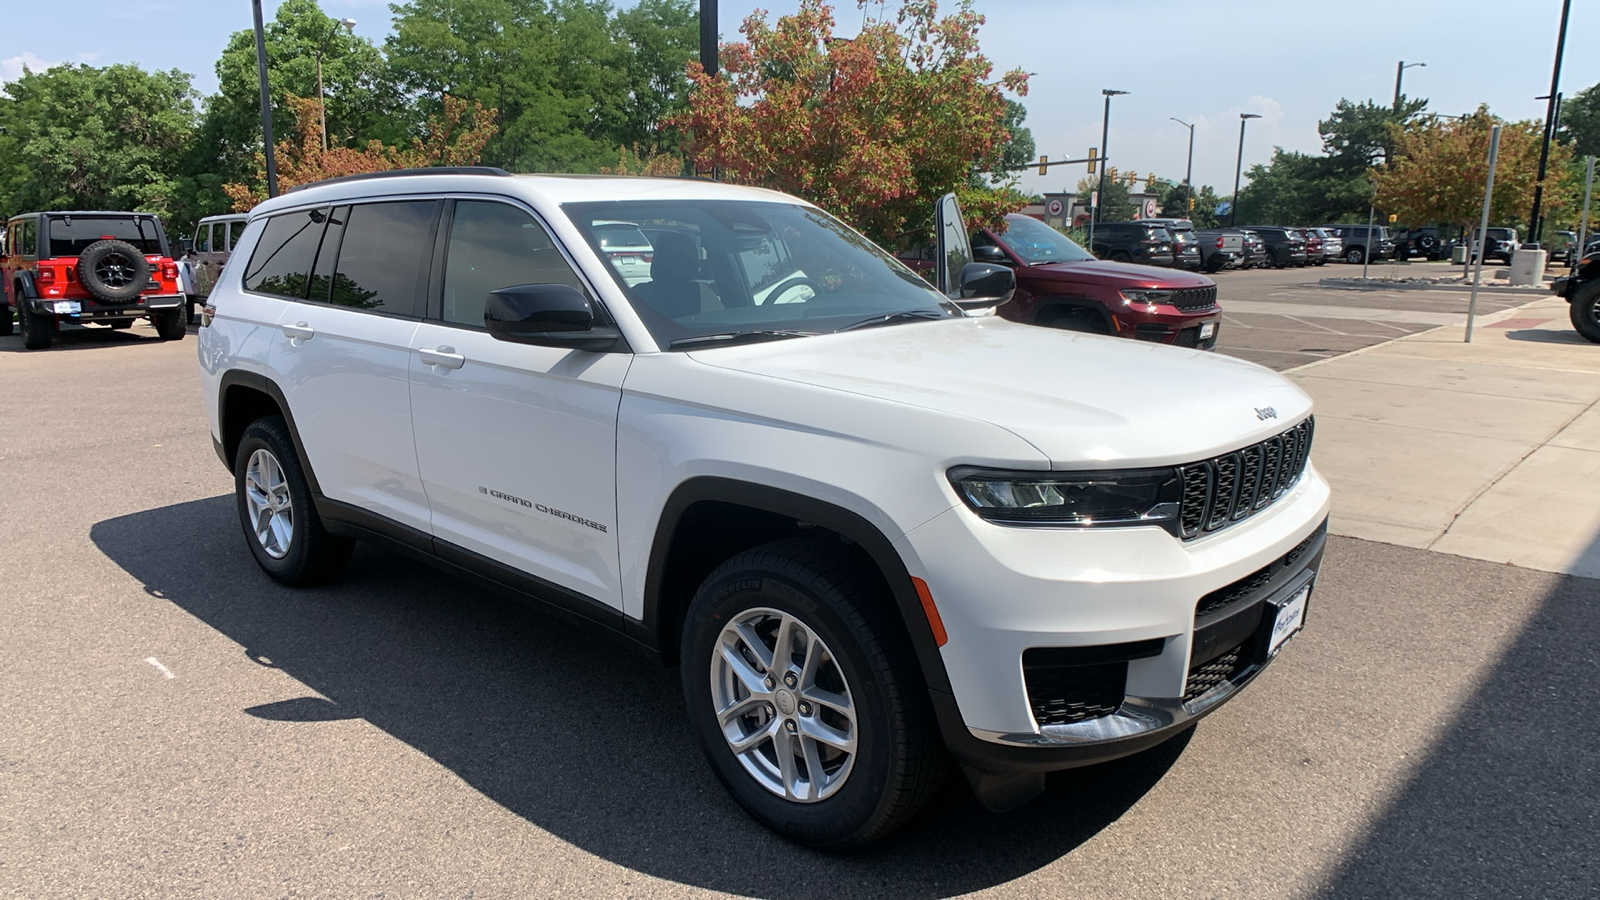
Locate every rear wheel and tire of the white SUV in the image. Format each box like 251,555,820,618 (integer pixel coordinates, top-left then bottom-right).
234,416,354,586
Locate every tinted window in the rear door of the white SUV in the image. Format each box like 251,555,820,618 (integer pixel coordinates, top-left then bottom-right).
317,200,438,319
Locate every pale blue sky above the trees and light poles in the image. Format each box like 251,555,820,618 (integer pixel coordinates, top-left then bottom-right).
0,0,1600,194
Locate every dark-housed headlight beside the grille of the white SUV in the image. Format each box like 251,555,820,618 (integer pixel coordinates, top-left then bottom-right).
950,468,1182,527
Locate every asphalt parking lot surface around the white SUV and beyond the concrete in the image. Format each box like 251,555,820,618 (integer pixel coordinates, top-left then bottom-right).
0,283,1600,898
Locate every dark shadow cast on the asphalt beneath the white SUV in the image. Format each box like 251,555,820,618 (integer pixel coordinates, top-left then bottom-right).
90,495,1189,897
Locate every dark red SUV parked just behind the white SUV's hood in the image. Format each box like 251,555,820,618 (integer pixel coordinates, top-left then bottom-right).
901,213,1222,351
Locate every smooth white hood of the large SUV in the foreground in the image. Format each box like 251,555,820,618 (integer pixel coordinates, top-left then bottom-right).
688,315,1310,469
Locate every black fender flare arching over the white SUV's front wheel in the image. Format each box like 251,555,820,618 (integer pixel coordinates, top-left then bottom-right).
629,476,952,693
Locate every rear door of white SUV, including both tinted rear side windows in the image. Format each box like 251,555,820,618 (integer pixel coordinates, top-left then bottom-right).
259,199,440,533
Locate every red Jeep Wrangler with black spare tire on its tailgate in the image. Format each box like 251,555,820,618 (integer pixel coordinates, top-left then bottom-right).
0,211,187,351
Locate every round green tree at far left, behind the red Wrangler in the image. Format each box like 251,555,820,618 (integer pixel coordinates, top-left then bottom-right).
0,64,195,218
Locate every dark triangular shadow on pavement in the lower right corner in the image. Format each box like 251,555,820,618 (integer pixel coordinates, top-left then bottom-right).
1323,560,1600,900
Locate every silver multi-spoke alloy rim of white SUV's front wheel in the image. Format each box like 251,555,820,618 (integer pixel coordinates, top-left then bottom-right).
710,609,859,802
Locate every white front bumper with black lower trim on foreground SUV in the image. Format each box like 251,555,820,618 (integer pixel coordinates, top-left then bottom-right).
898,466,1330,762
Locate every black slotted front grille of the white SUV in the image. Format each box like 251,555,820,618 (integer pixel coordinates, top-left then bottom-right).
1178,418,1314,540
